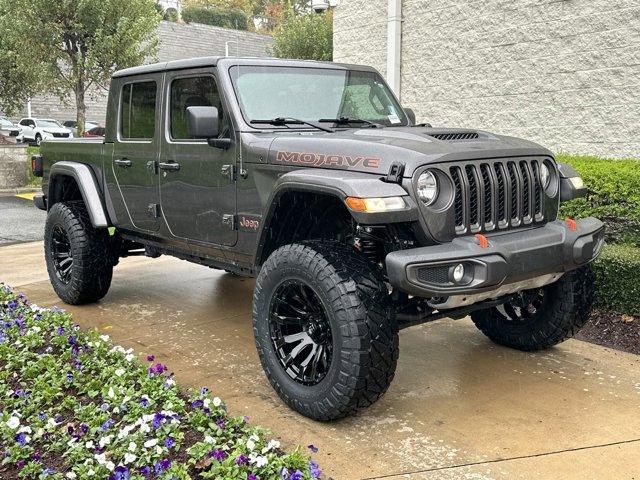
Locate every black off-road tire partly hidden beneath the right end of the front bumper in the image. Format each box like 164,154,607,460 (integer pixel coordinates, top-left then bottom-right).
471,265,594,351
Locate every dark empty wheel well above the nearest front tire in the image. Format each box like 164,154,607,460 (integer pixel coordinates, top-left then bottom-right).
257,190,355,265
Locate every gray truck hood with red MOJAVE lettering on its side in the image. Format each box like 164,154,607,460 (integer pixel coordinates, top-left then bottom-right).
269,126,552,177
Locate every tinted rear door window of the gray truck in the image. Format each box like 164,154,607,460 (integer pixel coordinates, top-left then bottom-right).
120,81,157,140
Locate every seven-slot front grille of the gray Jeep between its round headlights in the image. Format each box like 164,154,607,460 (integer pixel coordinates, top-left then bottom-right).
449,160,544,235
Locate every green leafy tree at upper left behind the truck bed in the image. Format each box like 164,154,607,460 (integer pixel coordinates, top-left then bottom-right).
0,0,161,133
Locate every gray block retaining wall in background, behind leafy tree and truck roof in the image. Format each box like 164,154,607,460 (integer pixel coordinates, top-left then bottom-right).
0,22,273,124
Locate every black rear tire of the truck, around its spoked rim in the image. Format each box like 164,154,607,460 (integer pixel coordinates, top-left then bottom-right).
44,201,114,305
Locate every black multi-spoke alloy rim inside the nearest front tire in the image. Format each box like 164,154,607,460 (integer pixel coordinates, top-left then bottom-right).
269,280,333,386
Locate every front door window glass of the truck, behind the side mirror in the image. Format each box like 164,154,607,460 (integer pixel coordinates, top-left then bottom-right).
169,75,228,140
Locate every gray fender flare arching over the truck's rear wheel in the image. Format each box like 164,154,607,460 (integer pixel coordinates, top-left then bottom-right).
47,161,110,228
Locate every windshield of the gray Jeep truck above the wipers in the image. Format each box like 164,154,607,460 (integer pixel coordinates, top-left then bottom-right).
230,65,407,127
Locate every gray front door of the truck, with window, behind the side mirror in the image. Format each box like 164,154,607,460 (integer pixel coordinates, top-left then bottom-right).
159,68,237,245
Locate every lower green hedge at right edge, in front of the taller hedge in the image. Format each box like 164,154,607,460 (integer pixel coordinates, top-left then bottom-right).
593,245,640,316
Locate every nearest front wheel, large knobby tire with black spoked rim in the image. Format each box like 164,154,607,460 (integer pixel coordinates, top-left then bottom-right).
253,242,398,420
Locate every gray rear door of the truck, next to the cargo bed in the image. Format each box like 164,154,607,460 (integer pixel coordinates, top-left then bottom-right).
107,74,163,233
